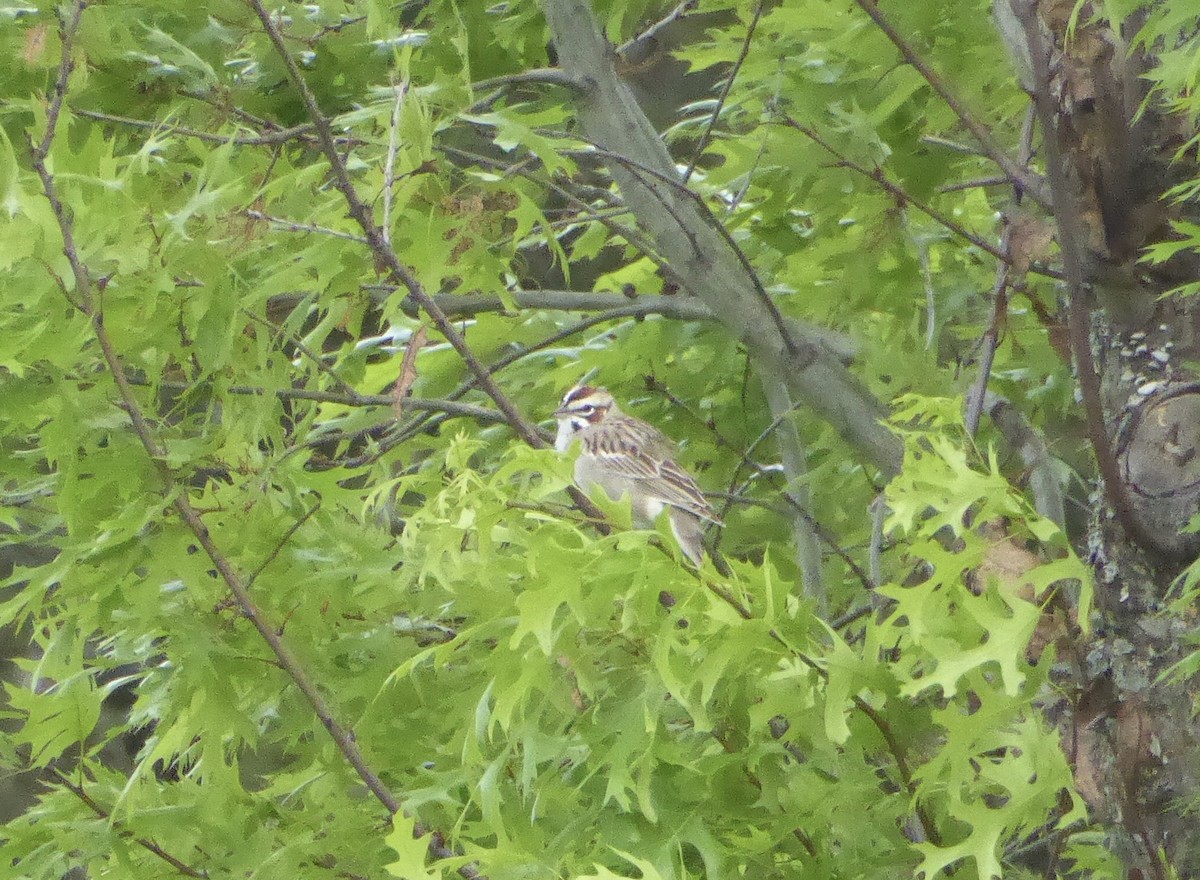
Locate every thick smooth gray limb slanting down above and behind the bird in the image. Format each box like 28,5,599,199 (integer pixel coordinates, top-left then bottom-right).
544,0,901,474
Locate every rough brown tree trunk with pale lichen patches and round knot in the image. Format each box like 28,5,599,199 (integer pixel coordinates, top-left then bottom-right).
996,0,1200,878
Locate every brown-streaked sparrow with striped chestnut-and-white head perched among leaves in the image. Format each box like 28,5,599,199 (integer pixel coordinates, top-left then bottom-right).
554,384,724,567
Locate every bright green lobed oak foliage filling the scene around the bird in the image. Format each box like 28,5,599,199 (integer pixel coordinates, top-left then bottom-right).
7,0,1180,880
